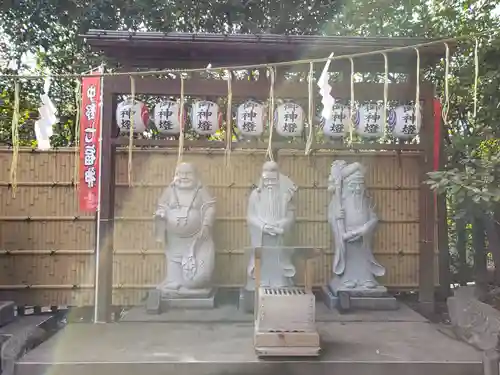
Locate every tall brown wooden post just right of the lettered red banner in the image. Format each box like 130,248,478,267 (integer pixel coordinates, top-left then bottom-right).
94,77,115,323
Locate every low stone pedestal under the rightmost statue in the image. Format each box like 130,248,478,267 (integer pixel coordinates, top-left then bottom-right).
322,286,399,310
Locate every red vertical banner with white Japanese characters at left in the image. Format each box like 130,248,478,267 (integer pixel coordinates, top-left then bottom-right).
78,73,101,212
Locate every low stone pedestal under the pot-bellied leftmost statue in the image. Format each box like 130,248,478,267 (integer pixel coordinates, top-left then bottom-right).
146,289,216,314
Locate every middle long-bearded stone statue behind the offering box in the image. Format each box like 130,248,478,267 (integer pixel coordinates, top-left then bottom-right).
245,161,297,291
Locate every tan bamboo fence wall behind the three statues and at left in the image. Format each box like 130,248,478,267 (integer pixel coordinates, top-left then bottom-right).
0,149,437,306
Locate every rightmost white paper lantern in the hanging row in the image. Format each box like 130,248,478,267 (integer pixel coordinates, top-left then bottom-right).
387,105,422,139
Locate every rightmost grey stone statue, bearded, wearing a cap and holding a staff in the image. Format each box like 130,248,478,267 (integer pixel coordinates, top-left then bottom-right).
328,160,386,295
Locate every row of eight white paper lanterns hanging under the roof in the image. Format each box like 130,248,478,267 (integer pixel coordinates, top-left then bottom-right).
116,100,422,139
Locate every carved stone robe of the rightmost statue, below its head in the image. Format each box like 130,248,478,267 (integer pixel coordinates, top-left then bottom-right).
328,191,385,291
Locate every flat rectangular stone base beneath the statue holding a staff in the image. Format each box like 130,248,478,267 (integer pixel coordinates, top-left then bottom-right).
322,286,399,310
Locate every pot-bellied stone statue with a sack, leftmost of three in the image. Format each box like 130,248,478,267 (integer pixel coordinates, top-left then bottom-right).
155,163,215,296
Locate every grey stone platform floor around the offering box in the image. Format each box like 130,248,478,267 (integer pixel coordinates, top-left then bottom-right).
16,306,482,375
